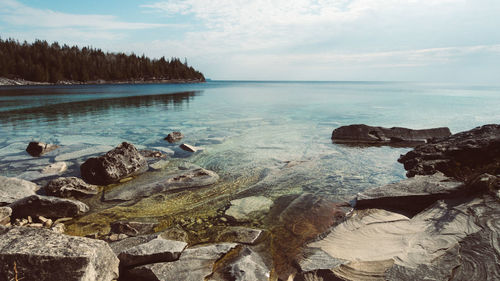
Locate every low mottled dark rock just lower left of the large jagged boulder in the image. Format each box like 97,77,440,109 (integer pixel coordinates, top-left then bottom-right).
44,177,98,198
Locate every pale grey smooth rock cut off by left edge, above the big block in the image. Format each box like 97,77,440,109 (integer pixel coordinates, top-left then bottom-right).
0,176,40,206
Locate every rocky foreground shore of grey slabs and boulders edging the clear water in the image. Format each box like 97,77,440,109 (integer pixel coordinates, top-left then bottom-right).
0,125,500,281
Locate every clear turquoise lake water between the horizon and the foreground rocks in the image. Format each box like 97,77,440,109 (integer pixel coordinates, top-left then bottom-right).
0,81,500,199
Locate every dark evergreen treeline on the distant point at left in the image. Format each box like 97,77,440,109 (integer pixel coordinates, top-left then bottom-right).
0,38,205,83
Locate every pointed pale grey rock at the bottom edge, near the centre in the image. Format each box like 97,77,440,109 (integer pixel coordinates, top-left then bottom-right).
207,246,271,281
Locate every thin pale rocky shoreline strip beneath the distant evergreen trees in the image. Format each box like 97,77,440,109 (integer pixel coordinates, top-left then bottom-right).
0,77,206,87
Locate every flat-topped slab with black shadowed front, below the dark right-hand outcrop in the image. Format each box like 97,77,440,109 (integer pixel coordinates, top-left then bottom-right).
355,173,464,214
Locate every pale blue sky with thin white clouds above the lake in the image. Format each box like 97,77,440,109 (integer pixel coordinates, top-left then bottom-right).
0,0,500,84
